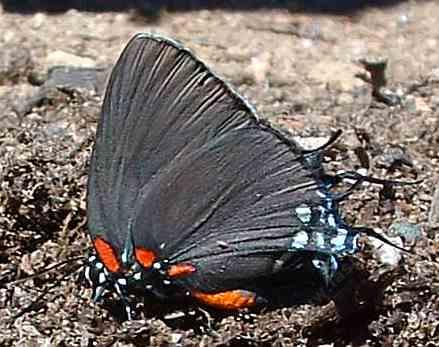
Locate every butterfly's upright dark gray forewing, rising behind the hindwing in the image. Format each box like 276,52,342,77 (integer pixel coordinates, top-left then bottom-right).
88,34,262,250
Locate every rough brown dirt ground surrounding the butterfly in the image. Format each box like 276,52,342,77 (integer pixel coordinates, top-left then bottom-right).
0,1,439,346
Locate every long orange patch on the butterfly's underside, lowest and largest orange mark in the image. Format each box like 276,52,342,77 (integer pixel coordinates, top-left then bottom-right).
192,290,256,310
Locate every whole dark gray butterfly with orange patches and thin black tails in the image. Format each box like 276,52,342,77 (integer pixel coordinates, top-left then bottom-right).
85,34,412,318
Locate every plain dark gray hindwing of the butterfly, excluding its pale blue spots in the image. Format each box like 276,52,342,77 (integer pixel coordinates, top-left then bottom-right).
133,124,328,291
